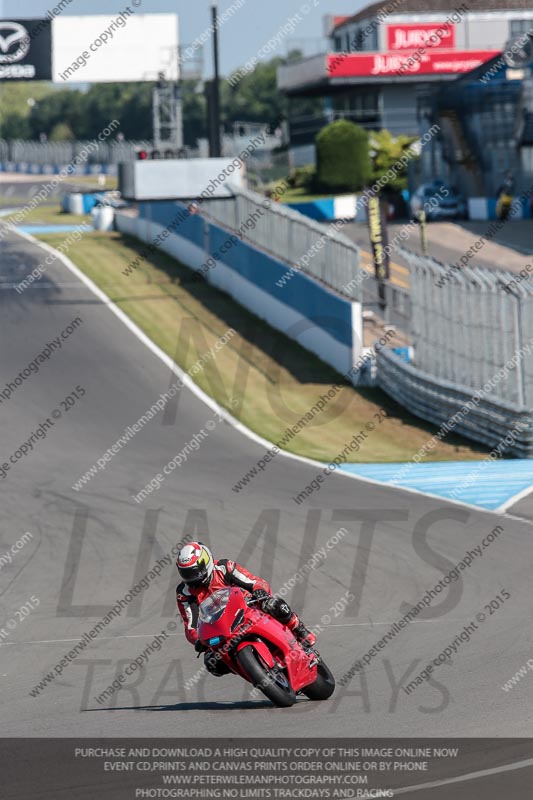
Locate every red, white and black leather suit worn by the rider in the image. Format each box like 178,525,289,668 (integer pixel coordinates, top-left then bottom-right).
176,558,316,644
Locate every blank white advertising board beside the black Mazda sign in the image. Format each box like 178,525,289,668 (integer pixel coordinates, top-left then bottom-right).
52,13,179,84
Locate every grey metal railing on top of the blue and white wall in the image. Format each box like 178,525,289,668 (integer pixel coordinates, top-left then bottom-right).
207,187,362,301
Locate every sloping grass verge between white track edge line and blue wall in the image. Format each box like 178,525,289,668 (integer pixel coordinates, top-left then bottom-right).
38,227,487,462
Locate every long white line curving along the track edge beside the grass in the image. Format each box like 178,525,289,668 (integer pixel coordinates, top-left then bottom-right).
7,229,528,515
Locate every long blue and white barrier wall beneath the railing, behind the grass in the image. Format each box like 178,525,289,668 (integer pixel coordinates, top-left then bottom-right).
129,201,362,373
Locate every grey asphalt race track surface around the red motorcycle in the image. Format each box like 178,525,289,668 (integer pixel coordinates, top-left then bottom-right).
0,222,533,797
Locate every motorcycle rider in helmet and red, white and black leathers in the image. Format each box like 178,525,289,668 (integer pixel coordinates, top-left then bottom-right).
176,542,316,676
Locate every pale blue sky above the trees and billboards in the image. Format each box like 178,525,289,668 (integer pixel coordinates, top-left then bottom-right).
0,0,370,75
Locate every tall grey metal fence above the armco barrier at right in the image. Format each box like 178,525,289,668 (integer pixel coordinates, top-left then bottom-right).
401,250,533,408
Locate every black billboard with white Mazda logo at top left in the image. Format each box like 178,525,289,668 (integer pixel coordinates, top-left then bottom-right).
0,19,52,81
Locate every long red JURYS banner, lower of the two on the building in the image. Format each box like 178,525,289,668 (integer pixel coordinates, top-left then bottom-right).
327,50,500,78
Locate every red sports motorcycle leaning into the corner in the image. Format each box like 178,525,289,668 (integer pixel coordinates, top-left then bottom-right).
198,586,335,707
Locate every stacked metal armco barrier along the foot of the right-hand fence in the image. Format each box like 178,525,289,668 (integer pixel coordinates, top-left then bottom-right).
377,349,533,456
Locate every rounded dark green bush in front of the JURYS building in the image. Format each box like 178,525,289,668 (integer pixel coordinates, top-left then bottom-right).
316,119,372,192
